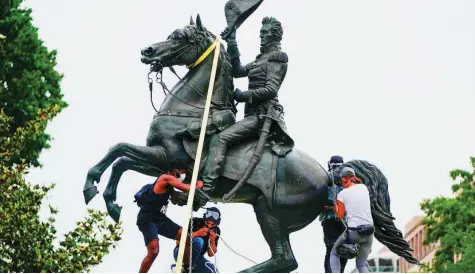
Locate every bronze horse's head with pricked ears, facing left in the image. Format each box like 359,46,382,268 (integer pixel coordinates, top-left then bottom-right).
141,14,216,70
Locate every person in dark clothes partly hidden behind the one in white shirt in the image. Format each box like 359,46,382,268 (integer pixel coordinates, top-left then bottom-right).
320,155,348,273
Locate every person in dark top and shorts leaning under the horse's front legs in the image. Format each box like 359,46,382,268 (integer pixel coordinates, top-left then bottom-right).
134,170,203,273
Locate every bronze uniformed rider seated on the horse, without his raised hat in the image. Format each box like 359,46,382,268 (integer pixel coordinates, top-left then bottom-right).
197,12,294,204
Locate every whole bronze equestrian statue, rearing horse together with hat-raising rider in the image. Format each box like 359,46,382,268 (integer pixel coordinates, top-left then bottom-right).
83,0,418,273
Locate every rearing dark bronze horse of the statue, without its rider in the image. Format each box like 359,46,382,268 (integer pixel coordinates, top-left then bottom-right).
84,15,418,272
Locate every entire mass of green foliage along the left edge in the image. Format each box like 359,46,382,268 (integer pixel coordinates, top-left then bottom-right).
0,0,122,273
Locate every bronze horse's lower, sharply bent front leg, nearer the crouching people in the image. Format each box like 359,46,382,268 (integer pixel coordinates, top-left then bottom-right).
103,157,164,223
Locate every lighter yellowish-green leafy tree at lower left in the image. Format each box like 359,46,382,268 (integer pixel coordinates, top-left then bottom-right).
0,106,122,273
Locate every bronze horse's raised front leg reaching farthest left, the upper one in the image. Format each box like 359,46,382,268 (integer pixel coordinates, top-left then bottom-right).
83,143,168,204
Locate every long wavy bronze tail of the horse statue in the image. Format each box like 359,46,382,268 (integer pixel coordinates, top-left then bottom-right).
334,160,420,265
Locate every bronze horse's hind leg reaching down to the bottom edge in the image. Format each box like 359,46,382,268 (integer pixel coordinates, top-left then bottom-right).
241,195,298,273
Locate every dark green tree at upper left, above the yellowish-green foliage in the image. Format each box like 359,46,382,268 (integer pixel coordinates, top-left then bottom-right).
0,0,67,166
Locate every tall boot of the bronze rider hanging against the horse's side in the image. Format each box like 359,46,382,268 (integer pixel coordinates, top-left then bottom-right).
196,134,226,206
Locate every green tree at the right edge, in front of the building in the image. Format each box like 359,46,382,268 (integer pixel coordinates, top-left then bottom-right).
421,157,475,273
